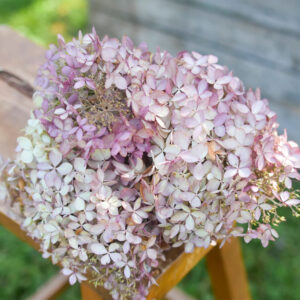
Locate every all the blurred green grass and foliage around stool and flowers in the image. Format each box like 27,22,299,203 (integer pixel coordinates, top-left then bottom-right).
0,0,300,300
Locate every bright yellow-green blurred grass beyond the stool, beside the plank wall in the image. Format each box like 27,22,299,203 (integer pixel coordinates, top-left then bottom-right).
0,0,87,46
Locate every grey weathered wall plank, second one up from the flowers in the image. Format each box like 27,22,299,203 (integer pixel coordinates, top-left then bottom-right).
91,0,300,74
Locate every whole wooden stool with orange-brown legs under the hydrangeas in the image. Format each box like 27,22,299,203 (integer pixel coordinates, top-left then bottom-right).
0,26,250,300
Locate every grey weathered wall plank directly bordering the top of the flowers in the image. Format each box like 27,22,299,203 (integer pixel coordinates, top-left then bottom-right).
91,11,300,142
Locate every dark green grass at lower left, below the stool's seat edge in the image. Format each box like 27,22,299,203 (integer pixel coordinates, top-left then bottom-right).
0,227,80,300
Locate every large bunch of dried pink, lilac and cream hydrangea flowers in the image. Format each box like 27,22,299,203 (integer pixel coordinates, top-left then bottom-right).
1,31,300,299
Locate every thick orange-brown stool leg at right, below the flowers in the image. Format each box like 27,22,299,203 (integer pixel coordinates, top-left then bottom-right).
206,238,251,300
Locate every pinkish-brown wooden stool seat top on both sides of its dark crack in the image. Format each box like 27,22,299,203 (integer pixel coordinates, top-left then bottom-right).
0,26,45,158
